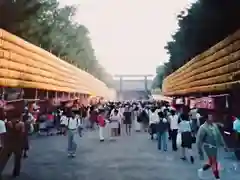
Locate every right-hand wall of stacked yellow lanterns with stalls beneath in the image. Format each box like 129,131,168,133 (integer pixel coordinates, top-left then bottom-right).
162,30,240,159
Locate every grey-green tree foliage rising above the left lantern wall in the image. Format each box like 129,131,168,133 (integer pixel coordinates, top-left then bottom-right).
0,0,112,86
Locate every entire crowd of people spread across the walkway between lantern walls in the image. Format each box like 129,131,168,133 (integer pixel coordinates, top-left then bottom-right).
0,101,240,179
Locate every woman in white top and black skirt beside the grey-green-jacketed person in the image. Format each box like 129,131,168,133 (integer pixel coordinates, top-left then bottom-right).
178,114,194,163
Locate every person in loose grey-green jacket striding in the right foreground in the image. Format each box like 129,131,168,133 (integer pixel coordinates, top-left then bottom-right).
197,114,227,180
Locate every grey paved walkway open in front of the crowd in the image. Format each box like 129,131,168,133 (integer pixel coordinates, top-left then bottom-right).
4,132,240,180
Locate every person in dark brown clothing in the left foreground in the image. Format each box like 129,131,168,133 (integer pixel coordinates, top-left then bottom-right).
0,112,25,179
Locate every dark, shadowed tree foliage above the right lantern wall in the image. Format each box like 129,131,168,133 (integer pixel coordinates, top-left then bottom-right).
156,0,240,86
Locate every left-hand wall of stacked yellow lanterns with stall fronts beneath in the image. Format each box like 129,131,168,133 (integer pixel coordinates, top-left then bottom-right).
0,29,114,114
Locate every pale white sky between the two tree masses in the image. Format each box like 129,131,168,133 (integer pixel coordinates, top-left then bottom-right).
59,0,195,75
